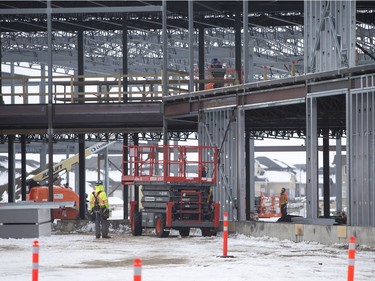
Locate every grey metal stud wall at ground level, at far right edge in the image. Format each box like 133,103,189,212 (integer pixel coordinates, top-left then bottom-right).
347,75,375,226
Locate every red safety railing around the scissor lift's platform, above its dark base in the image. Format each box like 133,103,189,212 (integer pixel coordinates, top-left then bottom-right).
122,145,218,184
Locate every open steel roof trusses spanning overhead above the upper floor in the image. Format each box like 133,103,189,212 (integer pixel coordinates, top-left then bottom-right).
0,1,375,81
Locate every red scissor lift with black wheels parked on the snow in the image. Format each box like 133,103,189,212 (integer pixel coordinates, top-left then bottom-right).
122,145,220,237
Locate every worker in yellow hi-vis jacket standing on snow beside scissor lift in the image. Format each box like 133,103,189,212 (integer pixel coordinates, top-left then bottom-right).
90,180,111,238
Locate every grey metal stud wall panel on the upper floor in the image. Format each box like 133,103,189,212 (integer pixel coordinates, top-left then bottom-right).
304,1,356,73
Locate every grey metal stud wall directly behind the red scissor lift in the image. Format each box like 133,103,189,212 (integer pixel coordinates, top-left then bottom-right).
198,109,246,220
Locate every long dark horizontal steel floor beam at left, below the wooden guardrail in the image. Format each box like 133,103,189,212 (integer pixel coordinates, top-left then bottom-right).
0,103,163,132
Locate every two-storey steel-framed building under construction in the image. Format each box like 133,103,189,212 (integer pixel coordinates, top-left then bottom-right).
0,0,375,243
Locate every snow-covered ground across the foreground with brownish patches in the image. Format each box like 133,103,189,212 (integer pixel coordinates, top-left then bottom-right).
0,226,375,281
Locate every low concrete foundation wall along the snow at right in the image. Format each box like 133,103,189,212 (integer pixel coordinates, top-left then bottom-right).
235,221,375,247
